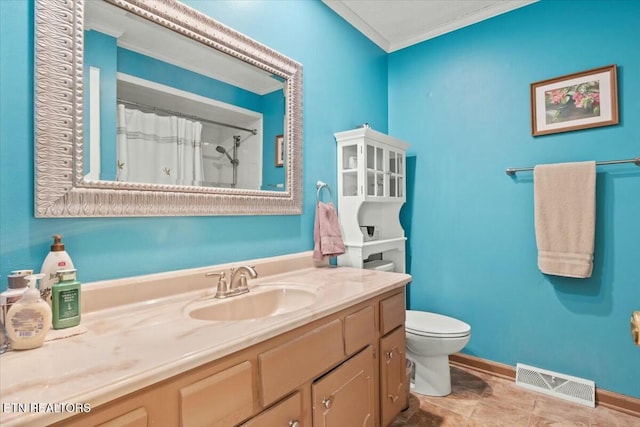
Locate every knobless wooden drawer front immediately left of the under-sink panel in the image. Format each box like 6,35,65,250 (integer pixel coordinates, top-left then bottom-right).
180,361,255,427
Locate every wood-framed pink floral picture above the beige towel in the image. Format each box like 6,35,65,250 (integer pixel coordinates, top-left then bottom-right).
531,64,619,136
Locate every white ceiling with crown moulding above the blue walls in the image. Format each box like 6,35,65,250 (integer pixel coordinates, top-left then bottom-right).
322,0,538,52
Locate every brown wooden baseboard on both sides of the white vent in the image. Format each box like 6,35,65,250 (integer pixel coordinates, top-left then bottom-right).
449,353,640,417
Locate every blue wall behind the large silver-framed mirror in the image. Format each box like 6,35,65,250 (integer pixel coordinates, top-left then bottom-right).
0,0,387,289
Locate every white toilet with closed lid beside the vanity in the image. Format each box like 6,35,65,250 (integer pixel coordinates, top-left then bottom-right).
405,310,471,396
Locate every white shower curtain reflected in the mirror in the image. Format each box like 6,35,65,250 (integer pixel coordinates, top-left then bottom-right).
117,104,203,185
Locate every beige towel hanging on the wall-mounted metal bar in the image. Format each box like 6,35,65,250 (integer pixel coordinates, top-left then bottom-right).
533,161,596,278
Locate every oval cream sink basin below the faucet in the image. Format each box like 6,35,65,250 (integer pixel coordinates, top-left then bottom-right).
188,285,318,321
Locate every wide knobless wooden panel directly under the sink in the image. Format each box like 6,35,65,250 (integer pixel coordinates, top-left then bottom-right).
258,319,344,406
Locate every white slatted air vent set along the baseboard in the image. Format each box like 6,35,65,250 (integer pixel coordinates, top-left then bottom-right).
516,363,596,408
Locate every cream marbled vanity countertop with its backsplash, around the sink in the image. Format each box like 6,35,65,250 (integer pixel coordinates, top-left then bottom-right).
0,252,411,427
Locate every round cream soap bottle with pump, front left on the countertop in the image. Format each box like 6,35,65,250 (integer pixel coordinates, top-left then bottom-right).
5,274,51,350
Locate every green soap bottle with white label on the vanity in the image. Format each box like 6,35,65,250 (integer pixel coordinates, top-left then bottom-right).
51,269,80,329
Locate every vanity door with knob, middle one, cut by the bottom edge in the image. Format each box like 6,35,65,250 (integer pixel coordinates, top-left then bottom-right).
312,346,377,427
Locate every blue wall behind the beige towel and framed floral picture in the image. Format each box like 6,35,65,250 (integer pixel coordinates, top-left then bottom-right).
389,1,640,397
